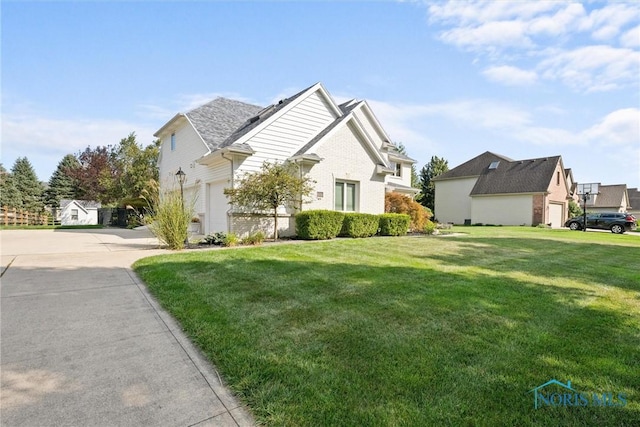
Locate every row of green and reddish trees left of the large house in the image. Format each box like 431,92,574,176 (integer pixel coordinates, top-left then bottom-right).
0,133,160,212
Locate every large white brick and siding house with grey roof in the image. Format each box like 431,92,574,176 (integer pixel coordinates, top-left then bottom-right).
155,83,419,235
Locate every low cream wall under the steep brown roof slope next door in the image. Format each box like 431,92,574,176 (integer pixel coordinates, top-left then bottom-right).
471,195,533,225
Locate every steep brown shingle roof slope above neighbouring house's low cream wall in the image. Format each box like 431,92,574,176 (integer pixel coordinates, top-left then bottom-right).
470,156,560,196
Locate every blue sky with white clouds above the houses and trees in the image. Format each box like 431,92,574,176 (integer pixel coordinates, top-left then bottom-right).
0,1,640,187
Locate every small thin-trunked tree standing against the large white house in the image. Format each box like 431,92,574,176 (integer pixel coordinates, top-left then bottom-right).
224,162,313,240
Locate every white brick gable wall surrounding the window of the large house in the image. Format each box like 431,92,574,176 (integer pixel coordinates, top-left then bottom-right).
303,124,385,214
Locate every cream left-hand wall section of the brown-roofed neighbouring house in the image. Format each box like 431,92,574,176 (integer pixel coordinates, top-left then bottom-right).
434,177,477,224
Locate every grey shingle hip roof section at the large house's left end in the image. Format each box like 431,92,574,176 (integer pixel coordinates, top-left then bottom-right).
186,98,262,150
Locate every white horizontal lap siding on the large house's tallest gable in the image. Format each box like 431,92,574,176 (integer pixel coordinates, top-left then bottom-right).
241,91,336,171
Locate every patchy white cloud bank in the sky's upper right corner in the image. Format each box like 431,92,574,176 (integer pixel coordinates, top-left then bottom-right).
427,0,640,92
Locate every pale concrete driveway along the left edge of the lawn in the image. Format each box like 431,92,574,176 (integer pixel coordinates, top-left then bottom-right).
0,229,253,426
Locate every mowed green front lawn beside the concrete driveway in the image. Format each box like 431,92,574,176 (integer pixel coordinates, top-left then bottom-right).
135,227,640,426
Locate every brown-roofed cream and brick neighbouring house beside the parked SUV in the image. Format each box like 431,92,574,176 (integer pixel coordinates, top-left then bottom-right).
433,151,571,227
